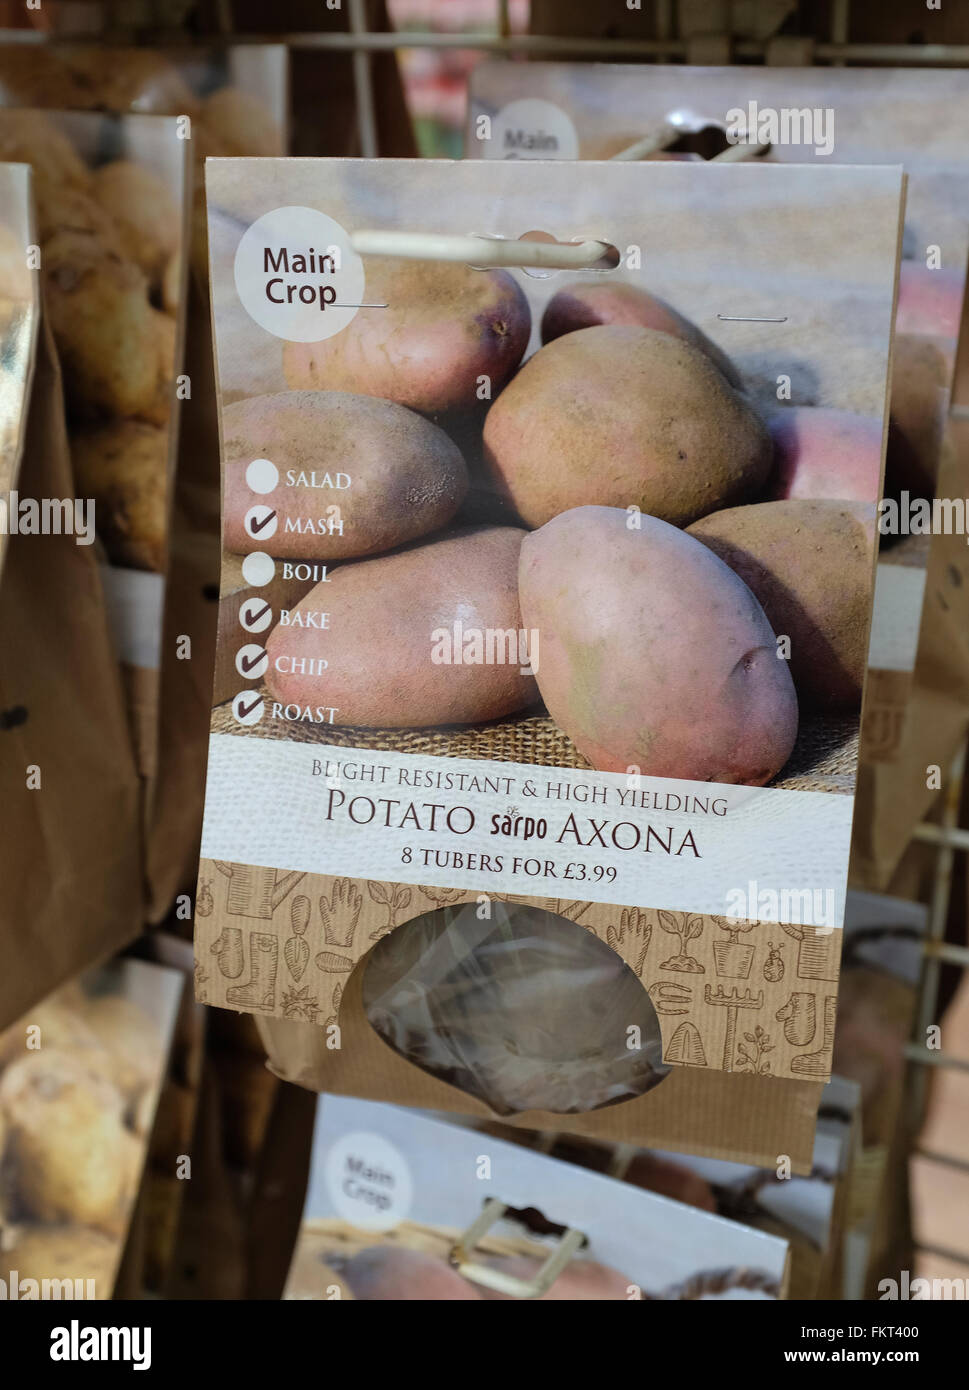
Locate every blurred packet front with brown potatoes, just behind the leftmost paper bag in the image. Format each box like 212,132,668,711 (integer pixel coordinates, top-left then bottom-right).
0,108,189,787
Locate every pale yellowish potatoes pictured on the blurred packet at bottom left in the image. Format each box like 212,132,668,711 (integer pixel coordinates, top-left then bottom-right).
0,986,163,1298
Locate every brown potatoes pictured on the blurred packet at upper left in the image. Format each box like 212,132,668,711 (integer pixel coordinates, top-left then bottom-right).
0,102,181,571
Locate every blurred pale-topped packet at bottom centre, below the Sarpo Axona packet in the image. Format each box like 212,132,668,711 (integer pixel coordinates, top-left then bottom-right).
284,1095,788,1302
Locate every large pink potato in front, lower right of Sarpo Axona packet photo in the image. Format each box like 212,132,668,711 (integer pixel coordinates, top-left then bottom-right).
519,507,798,787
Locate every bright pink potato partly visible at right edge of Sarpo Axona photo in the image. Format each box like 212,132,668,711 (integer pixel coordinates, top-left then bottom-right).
767,406,881,502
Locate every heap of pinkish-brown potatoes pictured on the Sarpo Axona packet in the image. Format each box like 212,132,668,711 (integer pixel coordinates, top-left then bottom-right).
222,260,881,785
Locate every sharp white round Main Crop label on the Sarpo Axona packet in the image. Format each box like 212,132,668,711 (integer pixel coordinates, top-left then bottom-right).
235,207,364,343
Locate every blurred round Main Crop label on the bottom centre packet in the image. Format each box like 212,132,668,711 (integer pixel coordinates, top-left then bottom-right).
324,1130,414,1230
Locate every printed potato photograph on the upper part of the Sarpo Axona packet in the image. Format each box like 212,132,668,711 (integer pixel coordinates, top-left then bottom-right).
209,161,898,794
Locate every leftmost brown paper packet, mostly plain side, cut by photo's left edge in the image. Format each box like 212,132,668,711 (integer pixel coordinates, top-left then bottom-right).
0,163,142,1027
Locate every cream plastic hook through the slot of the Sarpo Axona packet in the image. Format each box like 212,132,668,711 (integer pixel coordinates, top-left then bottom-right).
350,229,619,270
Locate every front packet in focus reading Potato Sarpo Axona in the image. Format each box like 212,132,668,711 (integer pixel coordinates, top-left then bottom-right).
196,160,902,1165
